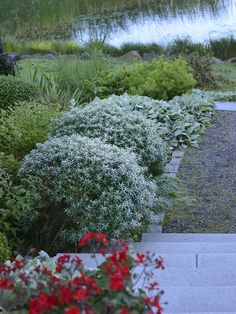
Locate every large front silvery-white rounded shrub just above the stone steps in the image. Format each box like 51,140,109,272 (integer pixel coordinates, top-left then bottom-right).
20,134,157,243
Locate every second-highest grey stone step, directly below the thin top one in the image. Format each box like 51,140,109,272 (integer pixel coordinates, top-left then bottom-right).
132,242,236,255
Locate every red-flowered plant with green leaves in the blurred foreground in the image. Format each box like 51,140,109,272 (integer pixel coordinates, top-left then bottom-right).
0,232,164,314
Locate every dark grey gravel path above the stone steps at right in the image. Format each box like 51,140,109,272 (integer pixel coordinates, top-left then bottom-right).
163,111,236,233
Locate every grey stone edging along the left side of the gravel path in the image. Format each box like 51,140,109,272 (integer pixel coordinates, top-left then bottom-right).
147,150,184,233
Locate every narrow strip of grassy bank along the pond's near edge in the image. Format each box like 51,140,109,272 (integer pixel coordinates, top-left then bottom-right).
3,36,236,60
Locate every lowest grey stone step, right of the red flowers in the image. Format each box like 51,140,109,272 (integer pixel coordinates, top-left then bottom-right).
161,288,236,314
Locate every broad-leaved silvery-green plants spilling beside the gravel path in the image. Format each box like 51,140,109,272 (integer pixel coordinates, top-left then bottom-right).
91,90,214,148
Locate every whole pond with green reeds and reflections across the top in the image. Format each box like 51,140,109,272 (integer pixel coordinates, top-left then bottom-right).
0,0,236,46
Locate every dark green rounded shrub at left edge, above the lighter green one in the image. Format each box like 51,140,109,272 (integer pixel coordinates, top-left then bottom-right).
0,75,37,109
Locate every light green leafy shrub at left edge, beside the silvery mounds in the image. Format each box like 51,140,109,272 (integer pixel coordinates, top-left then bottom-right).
0,101,62,159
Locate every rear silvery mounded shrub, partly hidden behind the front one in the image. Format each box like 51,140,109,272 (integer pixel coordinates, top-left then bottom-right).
51,97,167,175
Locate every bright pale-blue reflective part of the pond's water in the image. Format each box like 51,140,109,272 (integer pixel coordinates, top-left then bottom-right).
75,0,236,47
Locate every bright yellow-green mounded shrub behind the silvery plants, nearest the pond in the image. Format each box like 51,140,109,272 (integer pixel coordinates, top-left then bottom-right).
97,58,196,100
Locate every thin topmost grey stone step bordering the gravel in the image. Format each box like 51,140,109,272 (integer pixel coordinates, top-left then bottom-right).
142,233,236,243
